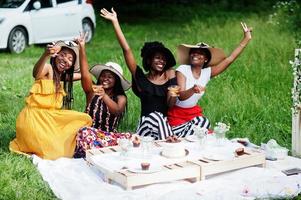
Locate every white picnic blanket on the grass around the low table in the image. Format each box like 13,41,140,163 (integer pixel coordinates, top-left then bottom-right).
33,156,301,200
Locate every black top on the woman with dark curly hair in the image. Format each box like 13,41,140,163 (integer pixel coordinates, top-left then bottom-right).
132,66,177,117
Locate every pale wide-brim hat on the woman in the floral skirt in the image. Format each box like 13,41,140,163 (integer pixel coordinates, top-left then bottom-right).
90,62,131,90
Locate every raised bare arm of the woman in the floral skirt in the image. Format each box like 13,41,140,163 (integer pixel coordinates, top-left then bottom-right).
75,33,94,104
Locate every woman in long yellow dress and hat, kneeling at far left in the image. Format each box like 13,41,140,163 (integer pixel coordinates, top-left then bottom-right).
9,41,92,160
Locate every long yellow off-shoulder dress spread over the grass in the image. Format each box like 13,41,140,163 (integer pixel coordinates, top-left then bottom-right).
9,80,92,160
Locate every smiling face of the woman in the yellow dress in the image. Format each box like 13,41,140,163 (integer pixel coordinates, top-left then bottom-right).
55,48,75,72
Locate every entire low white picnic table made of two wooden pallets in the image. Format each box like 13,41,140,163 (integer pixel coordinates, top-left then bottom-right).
86,142,265,190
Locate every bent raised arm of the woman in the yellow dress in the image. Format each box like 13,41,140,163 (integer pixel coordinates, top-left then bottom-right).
32,44,60,80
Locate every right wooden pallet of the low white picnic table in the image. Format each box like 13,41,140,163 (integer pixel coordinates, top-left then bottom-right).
192,150,266,180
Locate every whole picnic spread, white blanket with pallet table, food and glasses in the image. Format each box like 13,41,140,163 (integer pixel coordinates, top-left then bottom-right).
33,135,301,199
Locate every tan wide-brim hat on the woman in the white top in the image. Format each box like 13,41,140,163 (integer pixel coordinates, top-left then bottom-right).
178,42,226,66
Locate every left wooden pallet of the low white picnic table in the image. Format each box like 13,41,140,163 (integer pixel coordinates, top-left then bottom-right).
86,146,200,190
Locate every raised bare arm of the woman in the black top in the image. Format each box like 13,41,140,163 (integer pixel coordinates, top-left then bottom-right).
100,8,137,75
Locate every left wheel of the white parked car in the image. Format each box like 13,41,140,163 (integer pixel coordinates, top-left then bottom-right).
8,27,27,54
